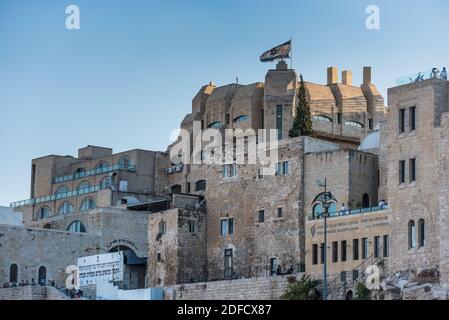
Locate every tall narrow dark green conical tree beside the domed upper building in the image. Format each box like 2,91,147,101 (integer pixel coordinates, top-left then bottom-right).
288,74,315,138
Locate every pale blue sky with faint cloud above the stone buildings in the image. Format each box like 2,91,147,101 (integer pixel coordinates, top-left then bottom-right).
0,0,449,205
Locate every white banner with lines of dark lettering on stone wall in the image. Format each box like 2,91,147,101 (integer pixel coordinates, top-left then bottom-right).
78,252,124,286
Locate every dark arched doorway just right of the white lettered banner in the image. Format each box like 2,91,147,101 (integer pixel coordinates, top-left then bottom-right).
109,245,147,290
